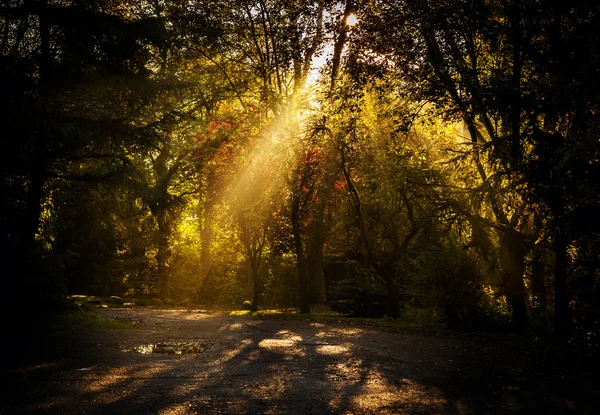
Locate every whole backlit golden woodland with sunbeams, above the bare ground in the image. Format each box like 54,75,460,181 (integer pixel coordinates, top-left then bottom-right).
0,0,600,360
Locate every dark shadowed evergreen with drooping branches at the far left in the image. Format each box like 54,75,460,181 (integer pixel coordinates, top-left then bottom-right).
0,0,172,308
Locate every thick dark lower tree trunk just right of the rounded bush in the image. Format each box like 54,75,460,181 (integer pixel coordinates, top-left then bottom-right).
500,229,529,333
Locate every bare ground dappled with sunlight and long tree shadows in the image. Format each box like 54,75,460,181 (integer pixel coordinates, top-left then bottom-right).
0,308,600,414
